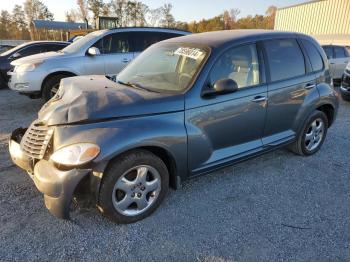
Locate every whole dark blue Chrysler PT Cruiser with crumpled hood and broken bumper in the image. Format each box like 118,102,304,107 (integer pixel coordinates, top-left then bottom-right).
9,30,338,223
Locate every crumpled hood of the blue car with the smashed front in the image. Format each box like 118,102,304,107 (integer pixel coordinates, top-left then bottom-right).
38,76,184,125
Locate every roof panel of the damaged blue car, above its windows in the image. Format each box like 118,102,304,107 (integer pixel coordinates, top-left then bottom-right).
164,29,295,48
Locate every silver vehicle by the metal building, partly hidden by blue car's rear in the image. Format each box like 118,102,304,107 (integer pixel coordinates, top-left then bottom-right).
322,45,350,82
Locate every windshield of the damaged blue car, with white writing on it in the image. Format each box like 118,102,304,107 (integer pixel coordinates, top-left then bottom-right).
117,43,208,92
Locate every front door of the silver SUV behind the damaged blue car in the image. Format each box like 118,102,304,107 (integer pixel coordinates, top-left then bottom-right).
103,32,134,75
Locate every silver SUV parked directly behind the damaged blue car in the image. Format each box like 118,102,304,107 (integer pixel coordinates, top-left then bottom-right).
10,28,189,101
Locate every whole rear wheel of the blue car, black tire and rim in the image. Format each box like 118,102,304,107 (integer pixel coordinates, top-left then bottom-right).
288,110,328,156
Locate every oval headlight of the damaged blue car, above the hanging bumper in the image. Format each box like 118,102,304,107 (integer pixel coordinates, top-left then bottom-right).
50,143,100,166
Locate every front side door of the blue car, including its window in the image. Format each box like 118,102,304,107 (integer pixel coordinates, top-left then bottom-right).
185,44,267,175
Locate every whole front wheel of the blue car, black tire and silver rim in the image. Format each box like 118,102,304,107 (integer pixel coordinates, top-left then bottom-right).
99,150,169,224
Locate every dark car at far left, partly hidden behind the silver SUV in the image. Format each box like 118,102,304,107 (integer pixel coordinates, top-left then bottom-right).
0,41,70,88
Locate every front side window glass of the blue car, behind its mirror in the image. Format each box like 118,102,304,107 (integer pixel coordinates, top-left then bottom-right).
210,44,260,88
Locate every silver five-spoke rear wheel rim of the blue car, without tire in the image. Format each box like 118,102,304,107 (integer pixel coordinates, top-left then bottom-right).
305,118,325,151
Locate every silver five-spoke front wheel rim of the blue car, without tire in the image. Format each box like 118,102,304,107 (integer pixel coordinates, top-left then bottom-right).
112,165,161,216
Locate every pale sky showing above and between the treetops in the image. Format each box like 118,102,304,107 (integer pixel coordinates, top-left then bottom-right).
0,0,306,22
